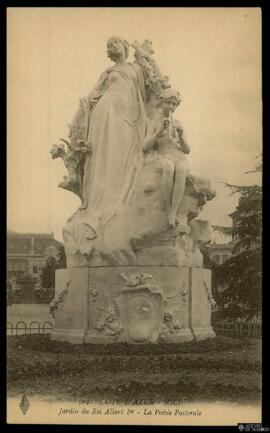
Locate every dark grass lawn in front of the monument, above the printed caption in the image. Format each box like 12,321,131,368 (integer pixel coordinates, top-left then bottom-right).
7,335,261,403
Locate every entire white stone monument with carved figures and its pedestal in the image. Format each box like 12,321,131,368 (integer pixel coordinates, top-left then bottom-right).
51,36,215,344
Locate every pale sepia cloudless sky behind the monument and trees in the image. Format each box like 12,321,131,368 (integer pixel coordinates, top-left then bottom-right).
7,8,262,241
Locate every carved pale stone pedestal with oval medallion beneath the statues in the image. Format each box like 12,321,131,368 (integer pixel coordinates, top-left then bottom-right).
51,266,215,344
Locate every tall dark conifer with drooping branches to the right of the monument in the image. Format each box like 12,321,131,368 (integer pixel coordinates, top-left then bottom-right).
203,157,262,315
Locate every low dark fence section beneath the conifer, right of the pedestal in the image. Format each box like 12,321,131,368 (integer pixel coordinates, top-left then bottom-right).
213,320,262,338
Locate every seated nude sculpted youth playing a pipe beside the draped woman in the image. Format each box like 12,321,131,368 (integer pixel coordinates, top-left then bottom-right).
143,88,190,231
